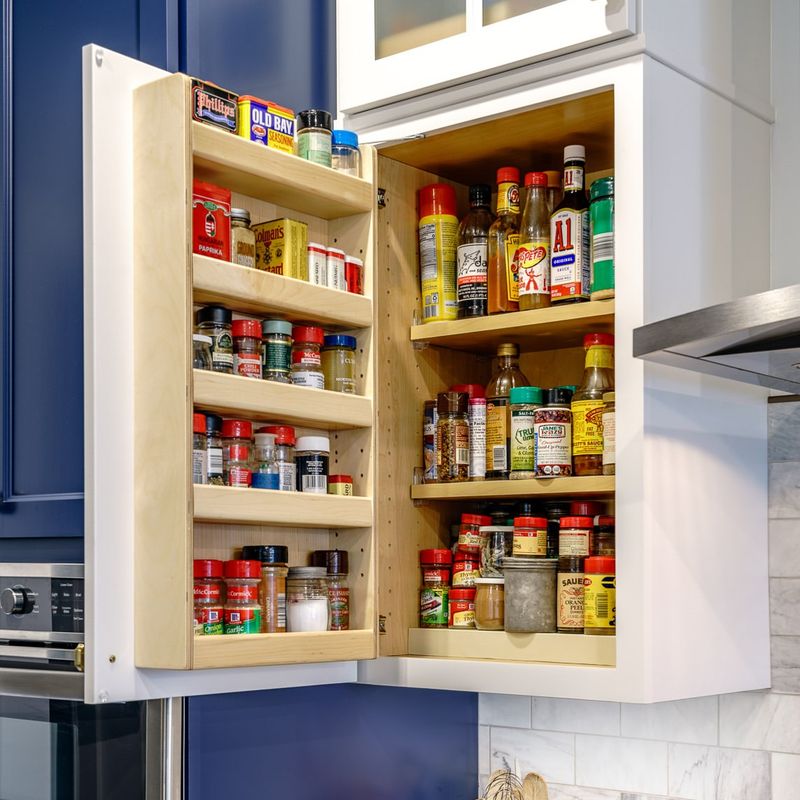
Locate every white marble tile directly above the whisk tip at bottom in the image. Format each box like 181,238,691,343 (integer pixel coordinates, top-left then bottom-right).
491,726,575,783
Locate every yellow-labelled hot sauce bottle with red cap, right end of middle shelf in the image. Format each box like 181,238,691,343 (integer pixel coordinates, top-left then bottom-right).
572,333,614,475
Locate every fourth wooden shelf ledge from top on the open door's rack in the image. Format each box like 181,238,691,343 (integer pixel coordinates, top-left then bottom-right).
194,486,372,528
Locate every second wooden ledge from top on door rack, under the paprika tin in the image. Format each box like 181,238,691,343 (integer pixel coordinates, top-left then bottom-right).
192,254,372,329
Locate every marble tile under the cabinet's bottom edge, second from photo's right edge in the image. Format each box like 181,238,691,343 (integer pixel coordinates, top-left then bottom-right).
622,697,718,744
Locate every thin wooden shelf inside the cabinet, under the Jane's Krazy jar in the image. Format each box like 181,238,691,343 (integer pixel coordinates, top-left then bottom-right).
411,475,614,500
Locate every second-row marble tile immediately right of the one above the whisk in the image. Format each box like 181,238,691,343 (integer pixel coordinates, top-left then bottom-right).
575,735,667,795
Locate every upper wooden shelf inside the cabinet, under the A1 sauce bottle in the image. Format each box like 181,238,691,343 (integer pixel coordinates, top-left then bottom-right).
411,300,614,355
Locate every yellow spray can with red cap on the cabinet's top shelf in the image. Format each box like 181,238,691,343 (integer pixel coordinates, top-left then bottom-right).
419,183,458,322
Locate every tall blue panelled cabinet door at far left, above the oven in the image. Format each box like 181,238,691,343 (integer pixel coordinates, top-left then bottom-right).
0,0,179,560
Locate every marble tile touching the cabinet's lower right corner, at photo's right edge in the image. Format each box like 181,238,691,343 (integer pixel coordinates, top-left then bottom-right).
719,692,800,753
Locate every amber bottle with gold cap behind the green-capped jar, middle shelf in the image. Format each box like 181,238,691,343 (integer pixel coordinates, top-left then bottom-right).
486,344,530,478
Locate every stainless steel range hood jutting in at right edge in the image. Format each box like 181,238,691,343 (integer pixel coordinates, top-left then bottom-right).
633,284,800,394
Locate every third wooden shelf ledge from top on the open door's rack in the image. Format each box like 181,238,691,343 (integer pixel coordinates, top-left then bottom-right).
194,370,372,430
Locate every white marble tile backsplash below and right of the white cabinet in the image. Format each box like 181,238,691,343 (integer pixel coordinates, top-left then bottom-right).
479,402,800,800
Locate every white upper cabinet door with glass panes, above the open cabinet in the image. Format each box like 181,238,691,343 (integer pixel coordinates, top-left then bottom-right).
337,0,636,113
